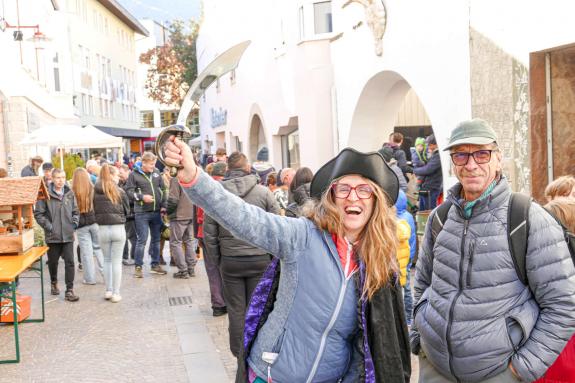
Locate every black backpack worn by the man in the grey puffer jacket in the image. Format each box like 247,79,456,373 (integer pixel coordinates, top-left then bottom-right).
431,193,575,285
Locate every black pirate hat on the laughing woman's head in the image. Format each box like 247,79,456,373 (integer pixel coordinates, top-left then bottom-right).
311,148,399,206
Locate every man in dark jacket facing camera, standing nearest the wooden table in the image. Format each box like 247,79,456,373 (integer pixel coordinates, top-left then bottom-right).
34,168,80,302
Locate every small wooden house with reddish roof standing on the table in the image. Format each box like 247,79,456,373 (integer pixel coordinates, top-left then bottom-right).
0,177,50,255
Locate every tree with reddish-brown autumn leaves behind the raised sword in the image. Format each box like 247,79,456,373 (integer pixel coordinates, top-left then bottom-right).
139,20,200,107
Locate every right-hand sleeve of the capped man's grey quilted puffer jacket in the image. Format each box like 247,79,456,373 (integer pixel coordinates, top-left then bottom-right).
511,204,575,382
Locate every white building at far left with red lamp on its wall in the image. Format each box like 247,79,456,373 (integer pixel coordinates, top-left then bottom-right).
0,0,78,176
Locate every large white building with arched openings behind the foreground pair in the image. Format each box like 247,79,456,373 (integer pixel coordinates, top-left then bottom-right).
197,0,575,198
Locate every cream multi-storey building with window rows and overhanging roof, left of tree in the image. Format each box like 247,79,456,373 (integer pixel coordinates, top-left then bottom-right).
65,0,149,159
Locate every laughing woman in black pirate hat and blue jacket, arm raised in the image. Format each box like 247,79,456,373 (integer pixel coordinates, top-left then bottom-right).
165,137,411,383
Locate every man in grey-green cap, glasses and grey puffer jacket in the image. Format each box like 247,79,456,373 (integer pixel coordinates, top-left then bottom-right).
411,119,575,383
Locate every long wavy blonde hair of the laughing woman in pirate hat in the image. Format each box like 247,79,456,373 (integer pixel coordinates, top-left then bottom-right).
304,178,399,299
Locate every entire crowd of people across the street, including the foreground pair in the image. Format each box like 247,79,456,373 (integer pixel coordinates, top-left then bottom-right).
1,119,575,383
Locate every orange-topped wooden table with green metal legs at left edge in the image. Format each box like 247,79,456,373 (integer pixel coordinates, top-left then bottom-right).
0,247,48,364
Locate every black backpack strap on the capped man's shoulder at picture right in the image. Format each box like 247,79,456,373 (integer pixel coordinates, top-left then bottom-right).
507,193,531,285
